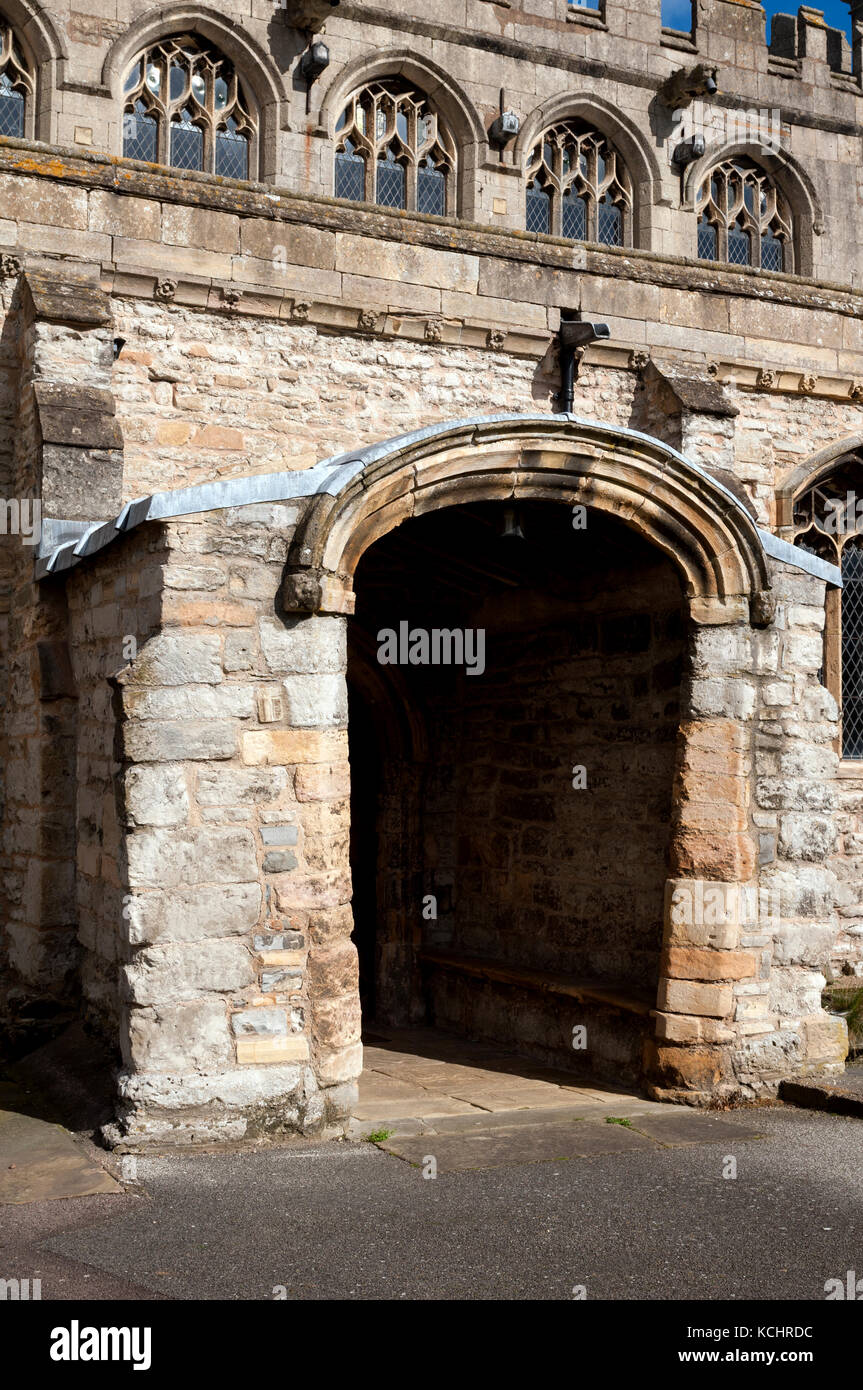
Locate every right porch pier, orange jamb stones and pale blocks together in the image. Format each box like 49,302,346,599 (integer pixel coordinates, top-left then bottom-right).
655,563,848,1098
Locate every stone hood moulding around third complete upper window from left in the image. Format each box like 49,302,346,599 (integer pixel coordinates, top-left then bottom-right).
513,92,661,252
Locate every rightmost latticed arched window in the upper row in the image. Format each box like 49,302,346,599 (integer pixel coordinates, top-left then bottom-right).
696,158,794,271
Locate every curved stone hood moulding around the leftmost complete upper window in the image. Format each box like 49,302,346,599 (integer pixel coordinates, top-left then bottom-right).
101,4,290,179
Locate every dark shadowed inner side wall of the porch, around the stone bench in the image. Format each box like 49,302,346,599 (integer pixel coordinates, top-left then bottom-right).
424,553,685,1066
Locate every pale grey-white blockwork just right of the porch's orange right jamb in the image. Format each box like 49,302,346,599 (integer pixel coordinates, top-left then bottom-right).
739,564,846,1083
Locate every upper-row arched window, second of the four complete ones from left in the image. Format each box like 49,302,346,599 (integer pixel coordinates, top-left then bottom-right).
335,79,456,217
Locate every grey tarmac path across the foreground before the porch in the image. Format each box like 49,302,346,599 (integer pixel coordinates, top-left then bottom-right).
0,1108,863,1301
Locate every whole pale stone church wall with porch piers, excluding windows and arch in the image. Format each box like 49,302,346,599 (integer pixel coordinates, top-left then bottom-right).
0,0,863,1133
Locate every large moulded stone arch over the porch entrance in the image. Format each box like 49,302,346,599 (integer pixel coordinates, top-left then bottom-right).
283,416,770,623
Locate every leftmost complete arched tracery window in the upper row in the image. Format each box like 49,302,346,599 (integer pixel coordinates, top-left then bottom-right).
122,33,257,179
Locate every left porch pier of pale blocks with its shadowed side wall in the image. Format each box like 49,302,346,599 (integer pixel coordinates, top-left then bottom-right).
64,506,359,1143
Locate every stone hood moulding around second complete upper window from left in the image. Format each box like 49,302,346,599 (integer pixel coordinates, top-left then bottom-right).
311,49,488,221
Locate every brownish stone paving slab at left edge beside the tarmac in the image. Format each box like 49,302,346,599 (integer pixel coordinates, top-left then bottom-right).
0,1081,122,1205
